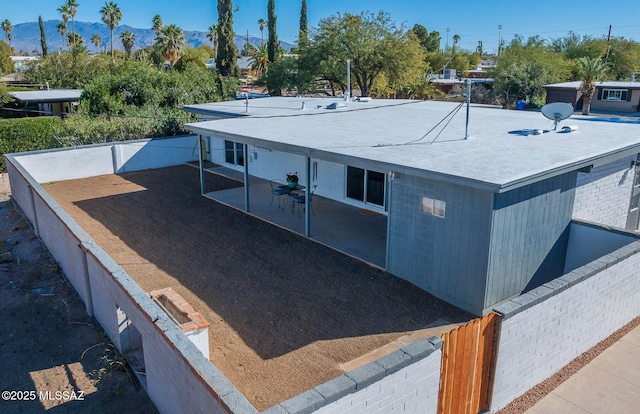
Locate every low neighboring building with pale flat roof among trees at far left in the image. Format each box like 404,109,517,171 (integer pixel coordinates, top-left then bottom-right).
9,89,82,116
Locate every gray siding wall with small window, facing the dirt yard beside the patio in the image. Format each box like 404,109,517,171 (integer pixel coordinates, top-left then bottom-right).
387,174,493,313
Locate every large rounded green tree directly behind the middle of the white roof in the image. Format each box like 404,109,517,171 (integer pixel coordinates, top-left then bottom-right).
301,12,425,96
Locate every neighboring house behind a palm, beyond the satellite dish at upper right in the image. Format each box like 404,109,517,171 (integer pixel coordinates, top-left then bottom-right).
544,81,640,112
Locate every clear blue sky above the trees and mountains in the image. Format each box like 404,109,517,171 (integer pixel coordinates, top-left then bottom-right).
0,0,640,52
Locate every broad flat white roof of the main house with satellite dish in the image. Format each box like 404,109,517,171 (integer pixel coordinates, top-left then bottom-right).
185,98,640,192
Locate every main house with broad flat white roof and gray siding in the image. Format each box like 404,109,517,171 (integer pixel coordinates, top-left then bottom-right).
185,98,640,314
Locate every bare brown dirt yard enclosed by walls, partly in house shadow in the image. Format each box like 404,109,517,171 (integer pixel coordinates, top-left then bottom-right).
44,166,472,410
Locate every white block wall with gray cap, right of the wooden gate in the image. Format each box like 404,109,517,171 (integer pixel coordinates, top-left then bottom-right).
491,241,640,412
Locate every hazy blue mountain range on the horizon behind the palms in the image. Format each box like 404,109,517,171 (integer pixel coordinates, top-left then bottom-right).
11,20,294,54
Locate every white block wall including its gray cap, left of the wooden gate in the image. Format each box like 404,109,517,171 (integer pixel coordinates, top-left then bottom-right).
262,337,442,414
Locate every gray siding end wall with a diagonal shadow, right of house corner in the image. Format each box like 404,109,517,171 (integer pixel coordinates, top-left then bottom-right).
484,172,576,309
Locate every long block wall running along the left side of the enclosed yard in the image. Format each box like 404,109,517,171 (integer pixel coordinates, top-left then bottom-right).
7,156,257,414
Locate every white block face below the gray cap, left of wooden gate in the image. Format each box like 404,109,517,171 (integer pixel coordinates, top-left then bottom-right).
315,349,442,414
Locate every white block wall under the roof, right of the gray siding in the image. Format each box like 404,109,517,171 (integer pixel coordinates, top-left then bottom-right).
573,156,636,228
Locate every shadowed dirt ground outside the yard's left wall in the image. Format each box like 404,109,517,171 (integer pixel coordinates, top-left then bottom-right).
0,175,157,413
